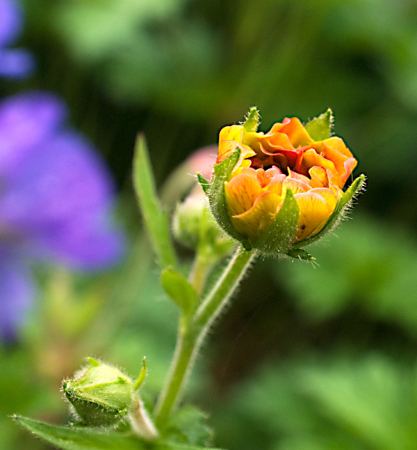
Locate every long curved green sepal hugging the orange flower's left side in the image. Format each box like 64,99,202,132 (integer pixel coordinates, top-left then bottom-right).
208,149,251,250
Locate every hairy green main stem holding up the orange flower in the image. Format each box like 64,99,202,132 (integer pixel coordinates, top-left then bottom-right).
154,247,255,426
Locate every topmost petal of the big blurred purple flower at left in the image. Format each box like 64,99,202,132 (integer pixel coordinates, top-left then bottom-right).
0,90,66,178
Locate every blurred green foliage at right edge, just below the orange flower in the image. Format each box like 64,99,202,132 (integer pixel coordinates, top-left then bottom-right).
275,215,417,337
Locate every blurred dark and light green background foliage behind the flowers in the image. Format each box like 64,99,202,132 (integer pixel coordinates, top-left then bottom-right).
0,0,417,450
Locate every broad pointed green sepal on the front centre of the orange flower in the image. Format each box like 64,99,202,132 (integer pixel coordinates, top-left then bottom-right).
251,189,299,256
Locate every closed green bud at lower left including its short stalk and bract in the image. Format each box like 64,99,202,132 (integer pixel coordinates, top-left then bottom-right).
62,358,158,440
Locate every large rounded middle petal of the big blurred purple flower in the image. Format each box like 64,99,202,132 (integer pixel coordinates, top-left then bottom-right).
0,132,113,223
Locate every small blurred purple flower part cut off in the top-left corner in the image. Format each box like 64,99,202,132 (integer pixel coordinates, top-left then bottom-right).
0,0,34,78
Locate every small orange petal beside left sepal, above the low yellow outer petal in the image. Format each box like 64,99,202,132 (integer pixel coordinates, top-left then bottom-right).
225,169,262,216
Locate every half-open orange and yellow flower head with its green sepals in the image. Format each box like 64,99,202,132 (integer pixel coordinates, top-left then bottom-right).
204,108,364,256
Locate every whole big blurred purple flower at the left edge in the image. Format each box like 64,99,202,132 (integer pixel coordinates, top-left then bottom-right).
0,92,123,338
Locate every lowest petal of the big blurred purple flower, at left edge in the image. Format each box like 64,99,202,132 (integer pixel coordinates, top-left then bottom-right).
0,248,35,340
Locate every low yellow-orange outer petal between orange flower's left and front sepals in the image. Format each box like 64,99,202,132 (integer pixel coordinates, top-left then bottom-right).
231,192,284,239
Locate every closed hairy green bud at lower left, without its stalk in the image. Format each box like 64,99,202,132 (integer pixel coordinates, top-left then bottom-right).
62,358,134,427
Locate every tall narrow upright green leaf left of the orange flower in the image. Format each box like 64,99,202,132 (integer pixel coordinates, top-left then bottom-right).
133,135,178,268
